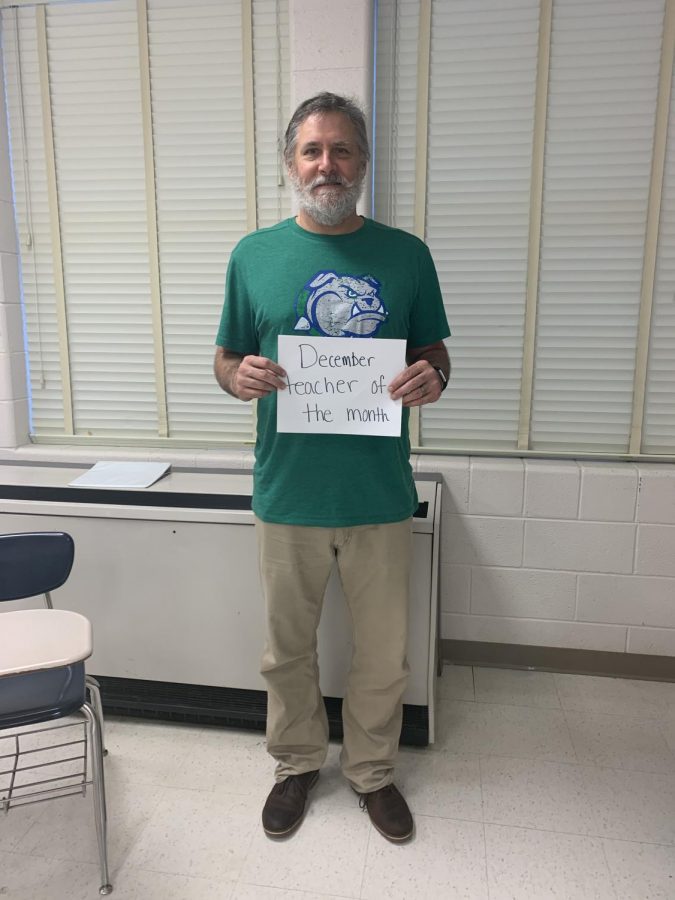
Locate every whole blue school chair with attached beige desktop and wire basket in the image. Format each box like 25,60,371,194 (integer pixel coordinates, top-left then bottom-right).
0,532,112,894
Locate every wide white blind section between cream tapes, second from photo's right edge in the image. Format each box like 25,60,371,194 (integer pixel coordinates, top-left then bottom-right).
531,0,664,453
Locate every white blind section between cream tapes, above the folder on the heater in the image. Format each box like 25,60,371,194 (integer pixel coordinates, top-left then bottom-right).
47,0,157,437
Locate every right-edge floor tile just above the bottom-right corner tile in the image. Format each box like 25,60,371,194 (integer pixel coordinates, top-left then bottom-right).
583,766,675,853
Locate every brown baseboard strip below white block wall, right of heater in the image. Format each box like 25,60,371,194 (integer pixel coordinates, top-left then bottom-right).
441,639,675,681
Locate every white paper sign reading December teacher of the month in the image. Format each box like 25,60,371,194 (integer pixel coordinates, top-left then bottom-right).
277,335,406,437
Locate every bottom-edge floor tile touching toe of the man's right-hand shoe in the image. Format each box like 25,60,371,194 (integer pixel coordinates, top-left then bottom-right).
361,816,488,900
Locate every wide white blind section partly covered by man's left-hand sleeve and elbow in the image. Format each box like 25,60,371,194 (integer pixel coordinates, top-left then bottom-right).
148,0,251,440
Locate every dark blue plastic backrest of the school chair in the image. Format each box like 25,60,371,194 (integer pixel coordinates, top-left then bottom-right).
0,531,75,601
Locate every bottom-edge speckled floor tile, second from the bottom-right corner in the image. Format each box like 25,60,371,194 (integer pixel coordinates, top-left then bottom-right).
485,825,614,900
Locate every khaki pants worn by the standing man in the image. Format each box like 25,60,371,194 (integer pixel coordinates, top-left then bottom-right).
256,519,412,792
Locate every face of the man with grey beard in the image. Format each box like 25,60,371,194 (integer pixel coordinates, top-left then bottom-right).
289,113,365,225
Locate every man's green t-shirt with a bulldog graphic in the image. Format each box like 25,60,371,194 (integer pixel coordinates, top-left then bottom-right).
216,219,450,528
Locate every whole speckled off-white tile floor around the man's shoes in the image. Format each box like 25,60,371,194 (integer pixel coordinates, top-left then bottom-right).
0,666,675,900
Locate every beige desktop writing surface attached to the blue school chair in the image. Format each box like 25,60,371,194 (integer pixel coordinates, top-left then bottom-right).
0,609,93,677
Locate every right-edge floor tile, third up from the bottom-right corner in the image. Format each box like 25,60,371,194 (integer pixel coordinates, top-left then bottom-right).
565,712,675,775
